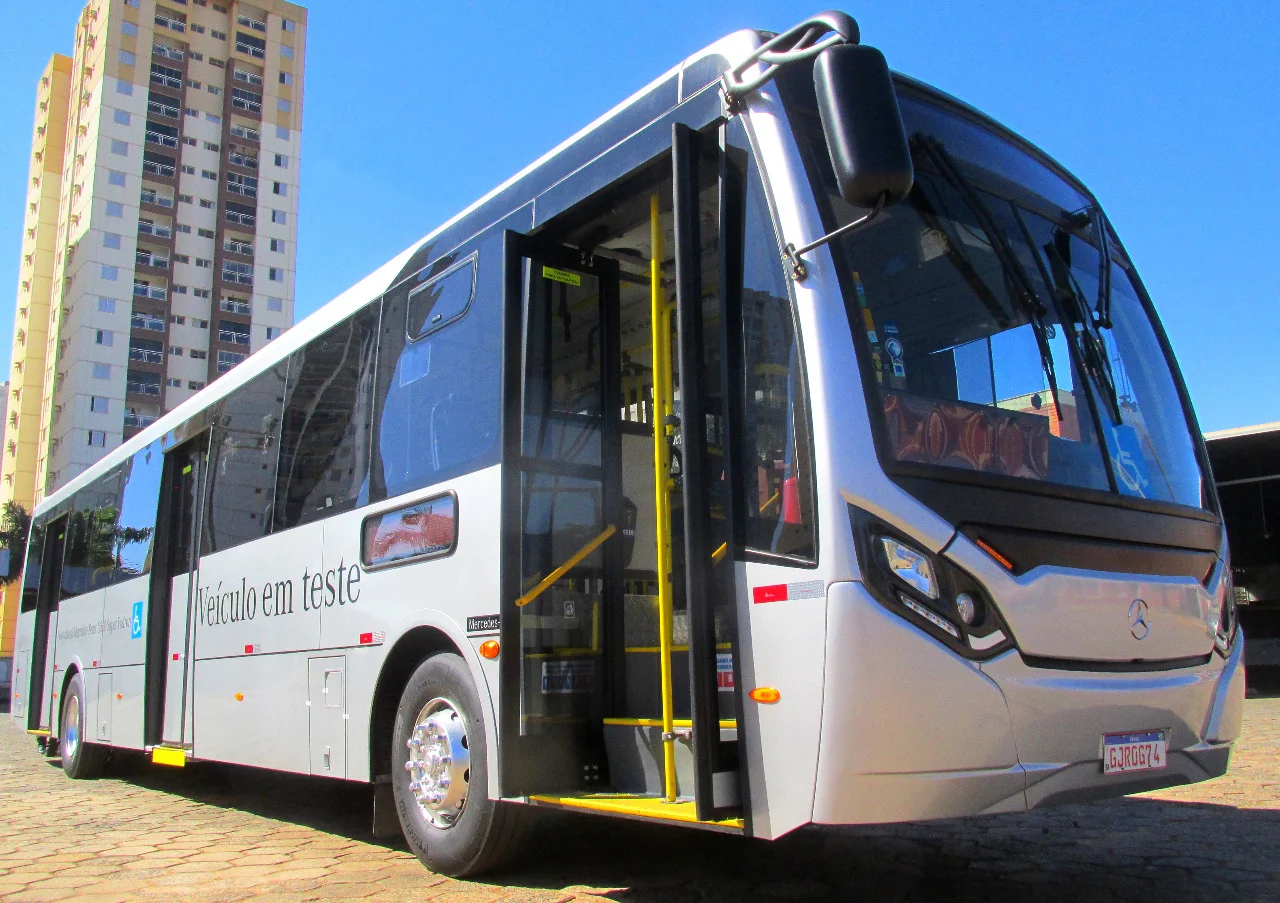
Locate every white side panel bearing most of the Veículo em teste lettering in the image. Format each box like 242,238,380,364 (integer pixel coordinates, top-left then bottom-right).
192,523,324,774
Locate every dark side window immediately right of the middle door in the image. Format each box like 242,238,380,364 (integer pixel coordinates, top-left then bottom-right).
200,364,287,555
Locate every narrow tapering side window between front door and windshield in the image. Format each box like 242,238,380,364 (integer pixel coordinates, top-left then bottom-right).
742,138,817,560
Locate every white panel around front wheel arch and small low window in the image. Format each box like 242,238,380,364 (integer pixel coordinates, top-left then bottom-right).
335,466,502,788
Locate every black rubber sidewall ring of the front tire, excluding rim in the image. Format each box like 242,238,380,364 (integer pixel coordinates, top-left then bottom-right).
390,653,500,877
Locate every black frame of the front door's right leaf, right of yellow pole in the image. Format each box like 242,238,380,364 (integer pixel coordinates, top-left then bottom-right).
672,123,750,821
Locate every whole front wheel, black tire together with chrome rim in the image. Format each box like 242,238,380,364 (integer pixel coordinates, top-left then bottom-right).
390,653,527,877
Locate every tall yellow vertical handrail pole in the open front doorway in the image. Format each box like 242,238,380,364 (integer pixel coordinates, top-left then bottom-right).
649,195,676,803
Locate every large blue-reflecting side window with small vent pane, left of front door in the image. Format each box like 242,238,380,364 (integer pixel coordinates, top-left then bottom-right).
370,229,502,501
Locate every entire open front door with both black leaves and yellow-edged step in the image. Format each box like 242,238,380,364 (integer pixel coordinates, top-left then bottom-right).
499,127,745,830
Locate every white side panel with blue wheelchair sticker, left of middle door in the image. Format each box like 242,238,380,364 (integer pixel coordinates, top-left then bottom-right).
97,576,151,749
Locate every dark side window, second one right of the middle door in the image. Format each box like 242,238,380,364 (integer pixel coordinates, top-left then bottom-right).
275,305,379,530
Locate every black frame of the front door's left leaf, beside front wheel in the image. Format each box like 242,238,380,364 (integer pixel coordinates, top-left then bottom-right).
498,229,622,797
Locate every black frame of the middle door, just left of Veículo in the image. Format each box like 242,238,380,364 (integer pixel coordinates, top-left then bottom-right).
143,430,211,747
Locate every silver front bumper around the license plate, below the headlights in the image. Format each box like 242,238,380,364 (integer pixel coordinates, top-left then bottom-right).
813,583,1244,824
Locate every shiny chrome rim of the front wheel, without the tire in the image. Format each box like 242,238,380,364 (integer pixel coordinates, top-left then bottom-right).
404,697,471,830
